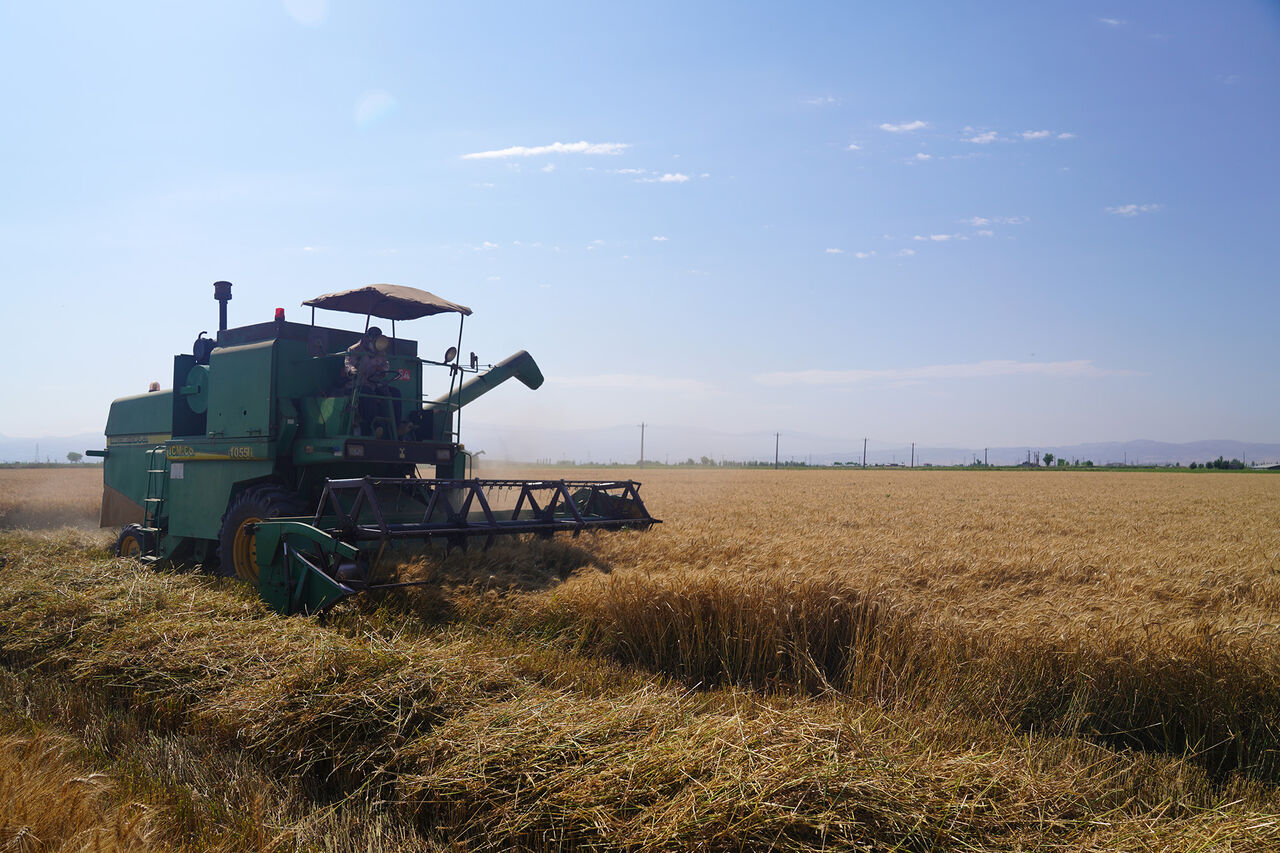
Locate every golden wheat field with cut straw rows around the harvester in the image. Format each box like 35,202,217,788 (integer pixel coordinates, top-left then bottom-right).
0,470,1280,850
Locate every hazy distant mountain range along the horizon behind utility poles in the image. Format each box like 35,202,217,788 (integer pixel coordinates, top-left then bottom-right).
0,423,1280,465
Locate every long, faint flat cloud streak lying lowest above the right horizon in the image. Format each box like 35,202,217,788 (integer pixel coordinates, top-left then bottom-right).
755,360,1137,386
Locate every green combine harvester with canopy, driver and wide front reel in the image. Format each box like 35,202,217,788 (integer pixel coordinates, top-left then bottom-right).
88,282,659,613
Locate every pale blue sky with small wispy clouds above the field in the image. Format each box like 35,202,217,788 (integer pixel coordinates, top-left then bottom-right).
0,0,1280,455
